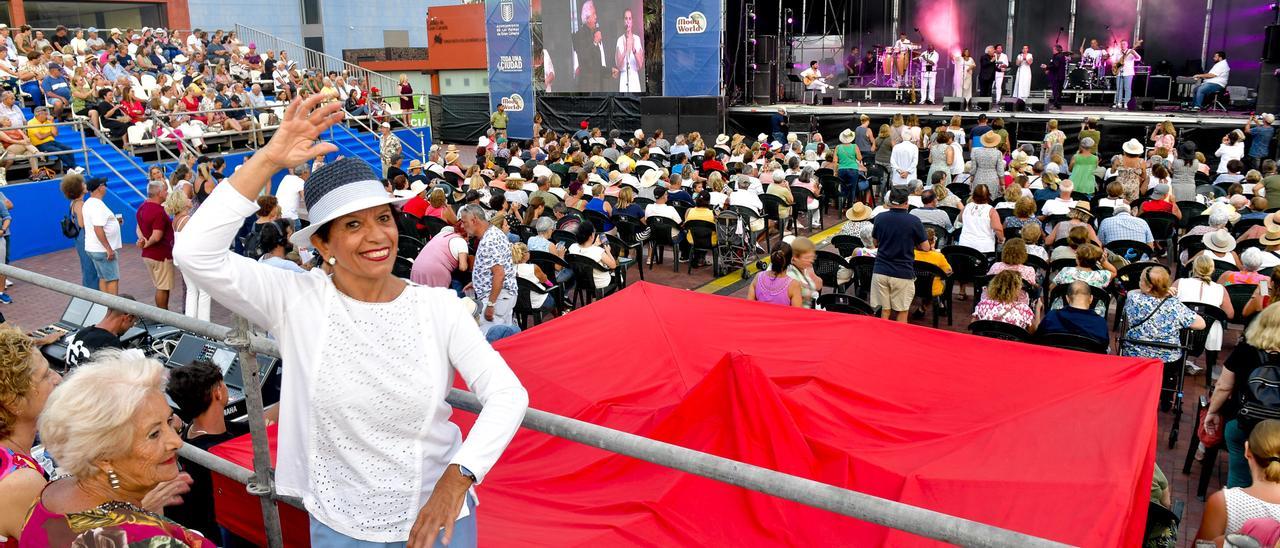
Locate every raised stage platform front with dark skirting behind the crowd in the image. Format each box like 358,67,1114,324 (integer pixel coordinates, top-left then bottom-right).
724,96,1249,156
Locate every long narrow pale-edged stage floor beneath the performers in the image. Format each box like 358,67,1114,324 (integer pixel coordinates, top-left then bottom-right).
728,101,1249,128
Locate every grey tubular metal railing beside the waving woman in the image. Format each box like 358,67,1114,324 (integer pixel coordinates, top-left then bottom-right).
0,265,1066,547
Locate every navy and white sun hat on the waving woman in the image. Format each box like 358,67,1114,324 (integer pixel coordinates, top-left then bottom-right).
289,157,408,247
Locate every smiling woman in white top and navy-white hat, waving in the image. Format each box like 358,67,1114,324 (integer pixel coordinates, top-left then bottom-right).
174,96,527,548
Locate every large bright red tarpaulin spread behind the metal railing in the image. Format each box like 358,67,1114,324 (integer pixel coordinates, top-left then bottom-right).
215,283,1161,547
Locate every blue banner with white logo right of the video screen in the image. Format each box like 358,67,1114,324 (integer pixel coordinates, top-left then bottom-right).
662,0,723,97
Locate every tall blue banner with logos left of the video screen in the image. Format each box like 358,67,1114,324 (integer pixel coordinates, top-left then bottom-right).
485,0,536,138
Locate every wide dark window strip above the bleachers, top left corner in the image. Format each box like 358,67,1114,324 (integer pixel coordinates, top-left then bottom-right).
24,1,169,28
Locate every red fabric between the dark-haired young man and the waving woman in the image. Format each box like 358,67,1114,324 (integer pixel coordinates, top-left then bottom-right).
209,425,311,548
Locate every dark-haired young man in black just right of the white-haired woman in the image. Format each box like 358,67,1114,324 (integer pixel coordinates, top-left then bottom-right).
165,361,254,545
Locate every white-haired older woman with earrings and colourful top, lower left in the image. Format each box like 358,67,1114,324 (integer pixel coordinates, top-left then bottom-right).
18,351,214,548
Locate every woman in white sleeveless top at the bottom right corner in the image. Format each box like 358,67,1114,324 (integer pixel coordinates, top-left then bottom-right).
1196,419,1280,545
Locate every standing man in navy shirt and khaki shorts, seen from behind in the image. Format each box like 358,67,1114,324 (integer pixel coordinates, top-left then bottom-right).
872,187,928,323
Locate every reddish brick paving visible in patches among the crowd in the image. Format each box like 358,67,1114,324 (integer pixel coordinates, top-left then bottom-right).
0,193,1239,547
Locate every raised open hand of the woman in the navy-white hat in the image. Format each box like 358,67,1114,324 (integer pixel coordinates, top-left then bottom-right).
257,93,346,169
